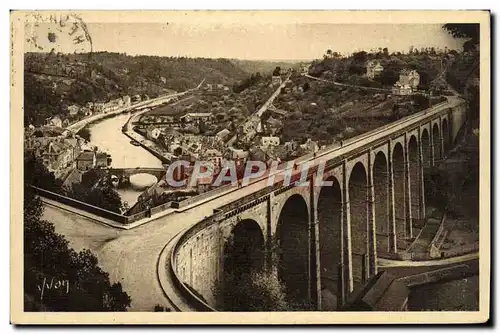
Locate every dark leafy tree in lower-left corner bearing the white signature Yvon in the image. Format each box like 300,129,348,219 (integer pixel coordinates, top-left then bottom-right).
24,186,131,312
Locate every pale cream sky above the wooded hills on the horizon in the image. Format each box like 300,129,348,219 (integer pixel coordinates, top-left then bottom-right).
27,22,463,60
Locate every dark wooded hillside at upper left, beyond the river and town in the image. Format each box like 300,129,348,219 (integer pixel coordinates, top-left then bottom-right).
24,52,248,125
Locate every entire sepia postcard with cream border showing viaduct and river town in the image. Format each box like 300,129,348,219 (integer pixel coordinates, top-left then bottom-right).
10,11,491,324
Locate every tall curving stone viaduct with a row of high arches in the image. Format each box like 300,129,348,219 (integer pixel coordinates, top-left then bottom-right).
171,97,466,310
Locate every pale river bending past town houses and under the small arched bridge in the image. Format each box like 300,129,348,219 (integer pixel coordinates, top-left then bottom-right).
88,113,163,206
